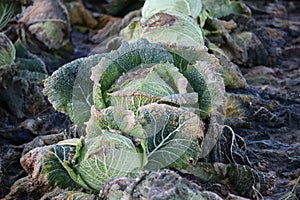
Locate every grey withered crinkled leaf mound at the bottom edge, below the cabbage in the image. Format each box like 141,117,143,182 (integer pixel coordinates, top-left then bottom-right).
122,170,222,200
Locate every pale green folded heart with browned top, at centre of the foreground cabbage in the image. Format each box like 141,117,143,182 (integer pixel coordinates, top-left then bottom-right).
108,63,188,113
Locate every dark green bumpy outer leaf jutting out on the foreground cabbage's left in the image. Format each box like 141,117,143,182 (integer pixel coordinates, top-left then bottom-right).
44,54,104,125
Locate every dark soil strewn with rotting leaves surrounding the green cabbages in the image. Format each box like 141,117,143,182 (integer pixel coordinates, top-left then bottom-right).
0,0,300,200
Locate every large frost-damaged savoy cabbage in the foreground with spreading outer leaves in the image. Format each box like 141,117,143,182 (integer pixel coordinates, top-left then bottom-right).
44,39,224,191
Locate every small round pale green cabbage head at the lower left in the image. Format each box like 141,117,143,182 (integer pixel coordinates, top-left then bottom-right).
63,131,144,192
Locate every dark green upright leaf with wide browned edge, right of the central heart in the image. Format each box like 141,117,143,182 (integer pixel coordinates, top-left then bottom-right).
163,44,225,119
